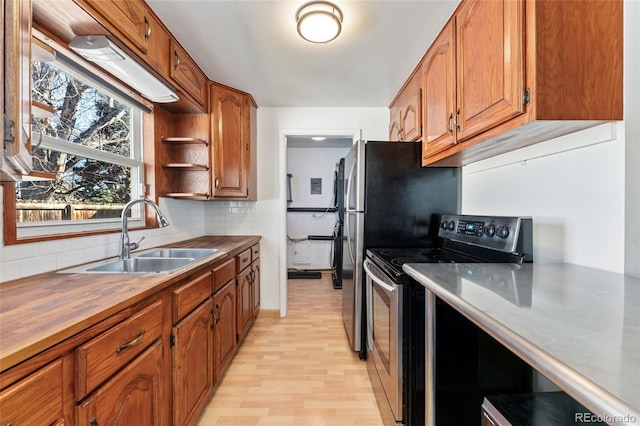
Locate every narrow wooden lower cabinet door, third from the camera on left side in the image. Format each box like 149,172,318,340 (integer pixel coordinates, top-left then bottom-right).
213,280,236,381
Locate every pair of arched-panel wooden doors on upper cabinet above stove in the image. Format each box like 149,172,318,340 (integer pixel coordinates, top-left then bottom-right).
423,0,525,162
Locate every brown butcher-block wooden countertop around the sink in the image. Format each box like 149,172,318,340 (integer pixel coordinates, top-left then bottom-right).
0,236,260,372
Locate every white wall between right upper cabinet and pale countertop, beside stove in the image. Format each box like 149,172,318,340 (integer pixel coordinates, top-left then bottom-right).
462,123,625,273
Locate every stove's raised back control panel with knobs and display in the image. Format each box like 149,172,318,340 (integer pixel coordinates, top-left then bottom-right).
438,215,531,253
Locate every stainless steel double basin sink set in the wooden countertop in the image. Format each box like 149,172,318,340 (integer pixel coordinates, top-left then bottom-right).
60,248,218,274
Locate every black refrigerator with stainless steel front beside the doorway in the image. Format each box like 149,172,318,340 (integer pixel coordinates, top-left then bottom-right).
342,141,461,359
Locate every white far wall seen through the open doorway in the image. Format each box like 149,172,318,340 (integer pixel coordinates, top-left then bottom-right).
287,147,349,270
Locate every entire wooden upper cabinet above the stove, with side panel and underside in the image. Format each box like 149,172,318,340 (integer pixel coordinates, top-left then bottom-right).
416,0,623,166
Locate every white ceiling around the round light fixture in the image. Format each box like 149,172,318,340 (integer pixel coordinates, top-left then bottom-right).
147,0,459,107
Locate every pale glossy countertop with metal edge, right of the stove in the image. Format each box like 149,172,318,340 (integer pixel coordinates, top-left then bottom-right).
403,263,640,425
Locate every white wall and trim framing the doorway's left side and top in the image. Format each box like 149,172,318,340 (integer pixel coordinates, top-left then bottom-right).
255,107,389,314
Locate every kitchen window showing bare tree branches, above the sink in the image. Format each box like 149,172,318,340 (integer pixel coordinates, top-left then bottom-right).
5,51,144,239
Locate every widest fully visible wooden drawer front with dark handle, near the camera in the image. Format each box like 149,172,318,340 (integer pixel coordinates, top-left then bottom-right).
76,301,162,400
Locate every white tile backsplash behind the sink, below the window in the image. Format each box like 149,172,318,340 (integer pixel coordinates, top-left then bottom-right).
0,195,205,282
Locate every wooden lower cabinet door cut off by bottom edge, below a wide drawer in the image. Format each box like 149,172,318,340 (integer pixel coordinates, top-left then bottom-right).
76,340,166,426
